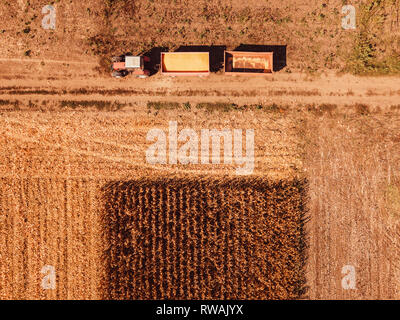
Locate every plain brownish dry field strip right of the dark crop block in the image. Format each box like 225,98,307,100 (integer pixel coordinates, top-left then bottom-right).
304,113,400,299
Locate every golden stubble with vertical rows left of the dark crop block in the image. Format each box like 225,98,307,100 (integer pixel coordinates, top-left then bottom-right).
0,176,102,299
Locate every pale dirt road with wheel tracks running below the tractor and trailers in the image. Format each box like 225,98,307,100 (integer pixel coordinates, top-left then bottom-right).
0,59,400,109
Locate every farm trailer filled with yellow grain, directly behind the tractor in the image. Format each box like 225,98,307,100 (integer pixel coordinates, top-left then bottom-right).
161,52,210,76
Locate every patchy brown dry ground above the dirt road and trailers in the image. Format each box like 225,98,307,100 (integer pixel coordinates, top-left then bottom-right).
0,0,400,76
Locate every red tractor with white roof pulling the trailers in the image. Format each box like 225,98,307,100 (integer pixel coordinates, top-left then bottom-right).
111,54,150,78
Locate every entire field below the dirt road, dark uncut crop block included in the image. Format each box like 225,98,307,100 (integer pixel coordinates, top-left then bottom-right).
0,105,400,299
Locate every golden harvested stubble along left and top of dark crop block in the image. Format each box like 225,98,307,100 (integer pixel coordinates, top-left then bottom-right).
0,107,301,299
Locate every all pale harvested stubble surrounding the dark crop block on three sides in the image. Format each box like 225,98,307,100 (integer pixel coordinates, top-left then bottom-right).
0,107,400,299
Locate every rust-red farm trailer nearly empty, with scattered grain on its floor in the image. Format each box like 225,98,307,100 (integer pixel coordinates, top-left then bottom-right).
224,51,274,74
